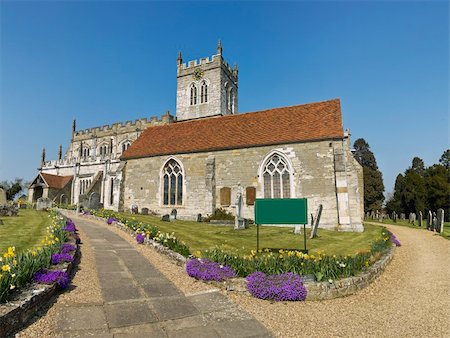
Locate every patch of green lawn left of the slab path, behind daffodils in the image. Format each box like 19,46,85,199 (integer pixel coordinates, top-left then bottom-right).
0,209,51,254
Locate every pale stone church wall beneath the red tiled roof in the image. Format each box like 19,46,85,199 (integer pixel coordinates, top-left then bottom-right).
122,140,362,230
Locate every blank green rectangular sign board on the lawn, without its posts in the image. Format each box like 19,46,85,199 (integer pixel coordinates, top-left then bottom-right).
255,198,308,224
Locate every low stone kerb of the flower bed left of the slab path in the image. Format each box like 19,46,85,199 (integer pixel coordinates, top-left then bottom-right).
0,238,80,337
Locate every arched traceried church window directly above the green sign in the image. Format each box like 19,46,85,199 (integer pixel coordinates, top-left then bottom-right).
262,153,292,198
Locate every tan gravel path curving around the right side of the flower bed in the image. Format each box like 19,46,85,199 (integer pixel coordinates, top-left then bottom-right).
230,225,450,337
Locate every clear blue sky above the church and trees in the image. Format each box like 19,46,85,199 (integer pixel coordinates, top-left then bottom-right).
0,1,449,192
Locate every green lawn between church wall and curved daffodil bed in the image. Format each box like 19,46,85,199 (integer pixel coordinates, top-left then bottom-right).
114,214,380,255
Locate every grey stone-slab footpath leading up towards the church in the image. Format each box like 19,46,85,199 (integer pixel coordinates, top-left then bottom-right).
56,218,272,338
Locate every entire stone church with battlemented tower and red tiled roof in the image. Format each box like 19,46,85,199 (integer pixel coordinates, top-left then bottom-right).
30,42,363,231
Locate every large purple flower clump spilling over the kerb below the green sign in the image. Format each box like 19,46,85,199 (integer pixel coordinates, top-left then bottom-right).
246,271,307,301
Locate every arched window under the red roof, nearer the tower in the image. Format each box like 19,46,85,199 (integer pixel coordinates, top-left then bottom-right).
162,159,183,205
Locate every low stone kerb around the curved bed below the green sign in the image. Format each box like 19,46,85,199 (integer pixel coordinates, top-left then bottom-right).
68,211,395,300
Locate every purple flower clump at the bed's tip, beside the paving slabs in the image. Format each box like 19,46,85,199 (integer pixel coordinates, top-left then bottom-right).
186,258,236,281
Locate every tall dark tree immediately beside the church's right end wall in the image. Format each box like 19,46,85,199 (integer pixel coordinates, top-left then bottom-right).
353,138,384,212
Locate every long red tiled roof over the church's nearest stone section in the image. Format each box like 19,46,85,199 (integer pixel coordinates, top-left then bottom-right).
121,99,344,160
